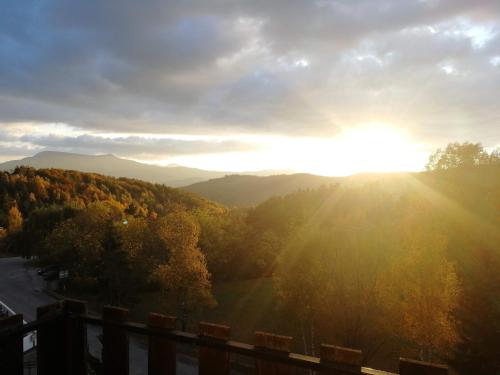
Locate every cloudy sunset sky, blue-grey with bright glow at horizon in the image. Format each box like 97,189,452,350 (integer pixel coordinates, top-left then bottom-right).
0,0,500,175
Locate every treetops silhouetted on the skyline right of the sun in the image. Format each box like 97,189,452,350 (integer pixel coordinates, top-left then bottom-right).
425,142,500,171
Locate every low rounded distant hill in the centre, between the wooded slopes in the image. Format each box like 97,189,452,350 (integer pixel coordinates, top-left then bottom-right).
183,173,344,207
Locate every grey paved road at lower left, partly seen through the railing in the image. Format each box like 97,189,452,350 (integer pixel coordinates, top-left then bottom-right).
0,258,198,375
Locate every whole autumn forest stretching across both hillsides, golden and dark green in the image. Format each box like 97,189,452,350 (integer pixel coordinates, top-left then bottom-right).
0,143,500,375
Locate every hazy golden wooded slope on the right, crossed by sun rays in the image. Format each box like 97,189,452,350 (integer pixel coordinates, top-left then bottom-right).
237,166,500,374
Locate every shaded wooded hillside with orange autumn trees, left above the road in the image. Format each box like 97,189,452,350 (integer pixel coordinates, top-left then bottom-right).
0,167,226,314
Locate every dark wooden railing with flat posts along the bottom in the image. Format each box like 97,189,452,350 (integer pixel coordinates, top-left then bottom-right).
0,300,448,375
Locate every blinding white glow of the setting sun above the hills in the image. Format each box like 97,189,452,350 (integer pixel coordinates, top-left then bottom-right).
160,123,428,176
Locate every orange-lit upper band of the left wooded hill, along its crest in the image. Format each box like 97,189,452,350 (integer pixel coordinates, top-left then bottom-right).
0,167,224,227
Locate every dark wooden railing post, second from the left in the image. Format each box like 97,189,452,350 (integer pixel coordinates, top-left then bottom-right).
36,302,68,375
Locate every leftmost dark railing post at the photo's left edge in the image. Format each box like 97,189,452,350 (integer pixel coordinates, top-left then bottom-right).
0,314,23,375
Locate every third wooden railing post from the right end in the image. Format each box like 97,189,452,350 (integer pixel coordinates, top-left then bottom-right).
255,332,295,375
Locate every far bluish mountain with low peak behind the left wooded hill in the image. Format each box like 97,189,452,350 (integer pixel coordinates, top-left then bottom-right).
0,151,228,187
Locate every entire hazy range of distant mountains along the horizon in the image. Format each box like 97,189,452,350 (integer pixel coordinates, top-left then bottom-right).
0,151,416,207
